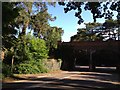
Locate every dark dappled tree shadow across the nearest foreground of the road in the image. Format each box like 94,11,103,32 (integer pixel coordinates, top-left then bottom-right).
2,78,120,90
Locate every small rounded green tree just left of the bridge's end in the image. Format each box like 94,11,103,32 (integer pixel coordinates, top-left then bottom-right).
44,27,63,55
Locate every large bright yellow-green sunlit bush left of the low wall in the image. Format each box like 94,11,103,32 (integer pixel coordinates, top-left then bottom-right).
14,34,48,74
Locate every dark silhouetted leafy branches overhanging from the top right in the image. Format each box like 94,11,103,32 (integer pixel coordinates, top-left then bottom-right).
58,0,120,24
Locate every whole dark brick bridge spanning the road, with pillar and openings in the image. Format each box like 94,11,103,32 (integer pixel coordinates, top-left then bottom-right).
58,41,120,70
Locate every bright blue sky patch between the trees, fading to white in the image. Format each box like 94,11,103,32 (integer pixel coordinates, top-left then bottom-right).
48,4,117,42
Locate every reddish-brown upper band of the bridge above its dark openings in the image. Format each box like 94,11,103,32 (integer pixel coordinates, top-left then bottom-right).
59,41,120,50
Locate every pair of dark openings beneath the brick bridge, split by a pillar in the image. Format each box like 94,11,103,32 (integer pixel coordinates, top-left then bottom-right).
74,50,119,71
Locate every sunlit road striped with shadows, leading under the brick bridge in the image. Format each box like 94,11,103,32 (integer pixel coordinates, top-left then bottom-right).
2,67,120,90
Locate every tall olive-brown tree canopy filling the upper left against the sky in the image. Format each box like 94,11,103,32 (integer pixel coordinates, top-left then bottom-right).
2,2,55,48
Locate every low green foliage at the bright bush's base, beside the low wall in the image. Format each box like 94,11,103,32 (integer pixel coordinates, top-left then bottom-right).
15,60,48,74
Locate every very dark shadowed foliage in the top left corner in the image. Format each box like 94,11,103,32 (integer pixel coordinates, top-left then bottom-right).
2,2,19,36
